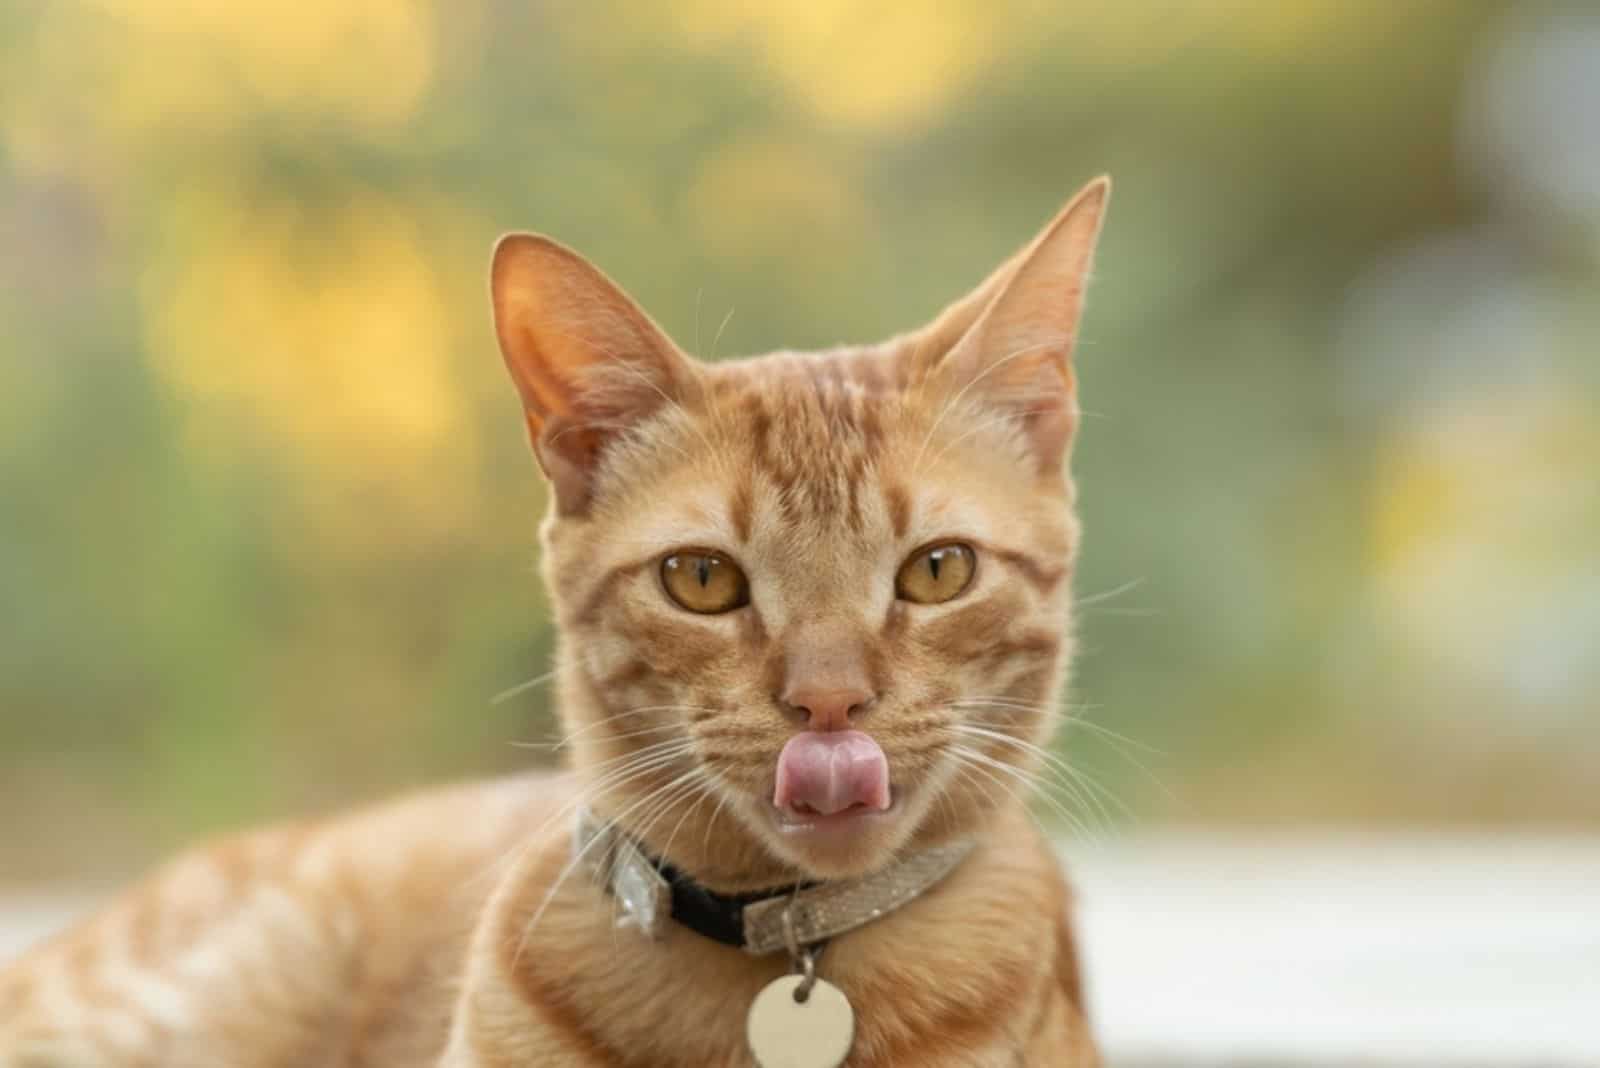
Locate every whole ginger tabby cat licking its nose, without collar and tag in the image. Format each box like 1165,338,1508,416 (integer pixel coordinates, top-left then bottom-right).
0,179,1109,1068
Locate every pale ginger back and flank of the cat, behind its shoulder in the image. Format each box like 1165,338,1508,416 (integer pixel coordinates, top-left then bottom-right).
0,775,540,1068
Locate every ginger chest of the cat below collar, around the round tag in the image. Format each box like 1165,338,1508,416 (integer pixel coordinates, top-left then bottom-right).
486,824,1062,1068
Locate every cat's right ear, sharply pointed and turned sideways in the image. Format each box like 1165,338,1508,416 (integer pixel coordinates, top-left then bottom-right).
914,177,1110,470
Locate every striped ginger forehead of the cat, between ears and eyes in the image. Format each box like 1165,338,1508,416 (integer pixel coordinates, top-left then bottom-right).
588,342,1036,549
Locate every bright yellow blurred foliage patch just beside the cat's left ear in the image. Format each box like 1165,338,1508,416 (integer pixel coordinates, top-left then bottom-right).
142,190,475,534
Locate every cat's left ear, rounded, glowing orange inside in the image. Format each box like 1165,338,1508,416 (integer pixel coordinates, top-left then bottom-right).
490,233,694,513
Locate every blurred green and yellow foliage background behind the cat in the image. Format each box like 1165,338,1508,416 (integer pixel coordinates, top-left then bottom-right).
0,0,1600,878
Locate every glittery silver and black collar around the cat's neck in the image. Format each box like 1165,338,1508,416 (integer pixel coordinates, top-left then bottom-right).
573,809,974,956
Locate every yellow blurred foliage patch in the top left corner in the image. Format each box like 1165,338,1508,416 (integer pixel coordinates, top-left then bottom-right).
0,0,437,177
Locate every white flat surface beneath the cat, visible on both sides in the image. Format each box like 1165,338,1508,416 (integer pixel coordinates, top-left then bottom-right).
0,835,1600,1068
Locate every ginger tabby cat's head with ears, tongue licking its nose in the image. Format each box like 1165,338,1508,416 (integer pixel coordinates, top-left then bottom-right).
493,179,1109,889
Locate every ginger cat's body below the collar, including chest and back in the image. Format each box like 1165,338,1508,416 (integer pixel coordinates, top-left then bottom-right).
0,775,1090,1068
